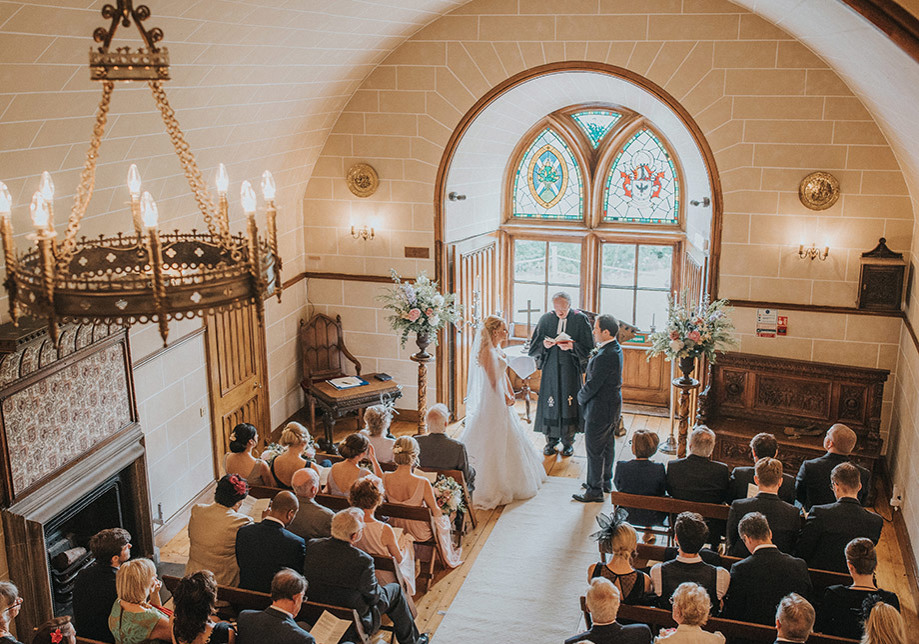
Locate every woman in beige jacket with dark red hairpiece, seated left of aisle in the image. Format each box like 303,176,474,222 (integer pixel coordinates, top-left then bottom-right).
185,474,252,586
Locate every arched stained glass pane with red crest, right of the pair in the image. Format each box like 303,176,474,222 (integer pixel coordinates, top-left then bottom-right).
604,128,680,224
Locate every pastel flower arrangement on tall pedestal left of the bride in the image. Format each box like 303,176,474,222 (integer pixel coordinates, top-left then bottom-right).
380,270,463,347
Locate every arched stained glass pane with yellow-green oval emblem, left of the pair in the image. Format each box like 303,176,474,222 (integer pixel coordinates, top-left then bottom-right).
514,128,584,220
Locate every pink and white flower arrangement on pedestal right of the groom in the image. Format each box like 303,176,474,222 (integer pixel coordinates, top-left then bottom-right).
648,293,737,362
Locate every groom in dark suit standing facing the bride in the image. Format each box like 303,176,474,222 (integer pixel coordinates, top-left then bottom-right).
573,315,622,503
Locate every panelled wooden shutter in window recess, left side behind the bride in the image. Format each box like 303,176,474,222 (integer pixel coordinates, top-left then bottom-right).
447,234,498,418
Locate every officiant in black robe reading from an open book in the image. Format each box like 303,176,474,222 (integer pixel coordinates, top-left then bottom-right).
530,292,594,456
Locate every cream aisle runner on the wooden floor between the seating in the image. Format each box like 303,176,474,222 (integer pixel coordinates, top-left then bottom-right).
433,476,610,644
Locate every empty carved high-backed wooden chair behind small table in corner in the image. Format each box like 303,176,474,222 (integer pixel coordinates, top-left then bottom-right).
300,313,361,432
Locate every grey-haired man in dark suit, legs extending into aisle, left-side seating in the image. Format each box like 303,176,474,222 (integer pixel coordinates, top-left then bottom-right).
304,508,428,644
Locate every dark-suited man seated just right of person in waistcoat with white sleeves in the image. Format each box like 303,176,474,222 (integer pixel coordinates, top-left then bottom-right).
724,512,813,625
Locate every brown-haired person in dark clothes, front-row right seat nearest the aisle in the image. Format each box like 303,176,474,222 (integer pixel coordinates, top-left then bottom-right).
613,429,667,538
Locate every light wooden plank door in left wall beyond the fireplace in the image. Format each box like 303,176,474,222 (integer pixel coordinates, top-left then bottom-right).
205,306,271,476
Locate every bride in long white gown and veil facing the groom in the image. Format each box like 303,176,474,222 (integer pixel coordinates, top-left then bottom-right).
459,315,546,510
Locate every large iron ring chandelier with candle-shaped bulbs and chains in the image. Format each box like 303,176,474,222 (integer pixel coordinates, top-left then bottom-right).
0,0,281,344
